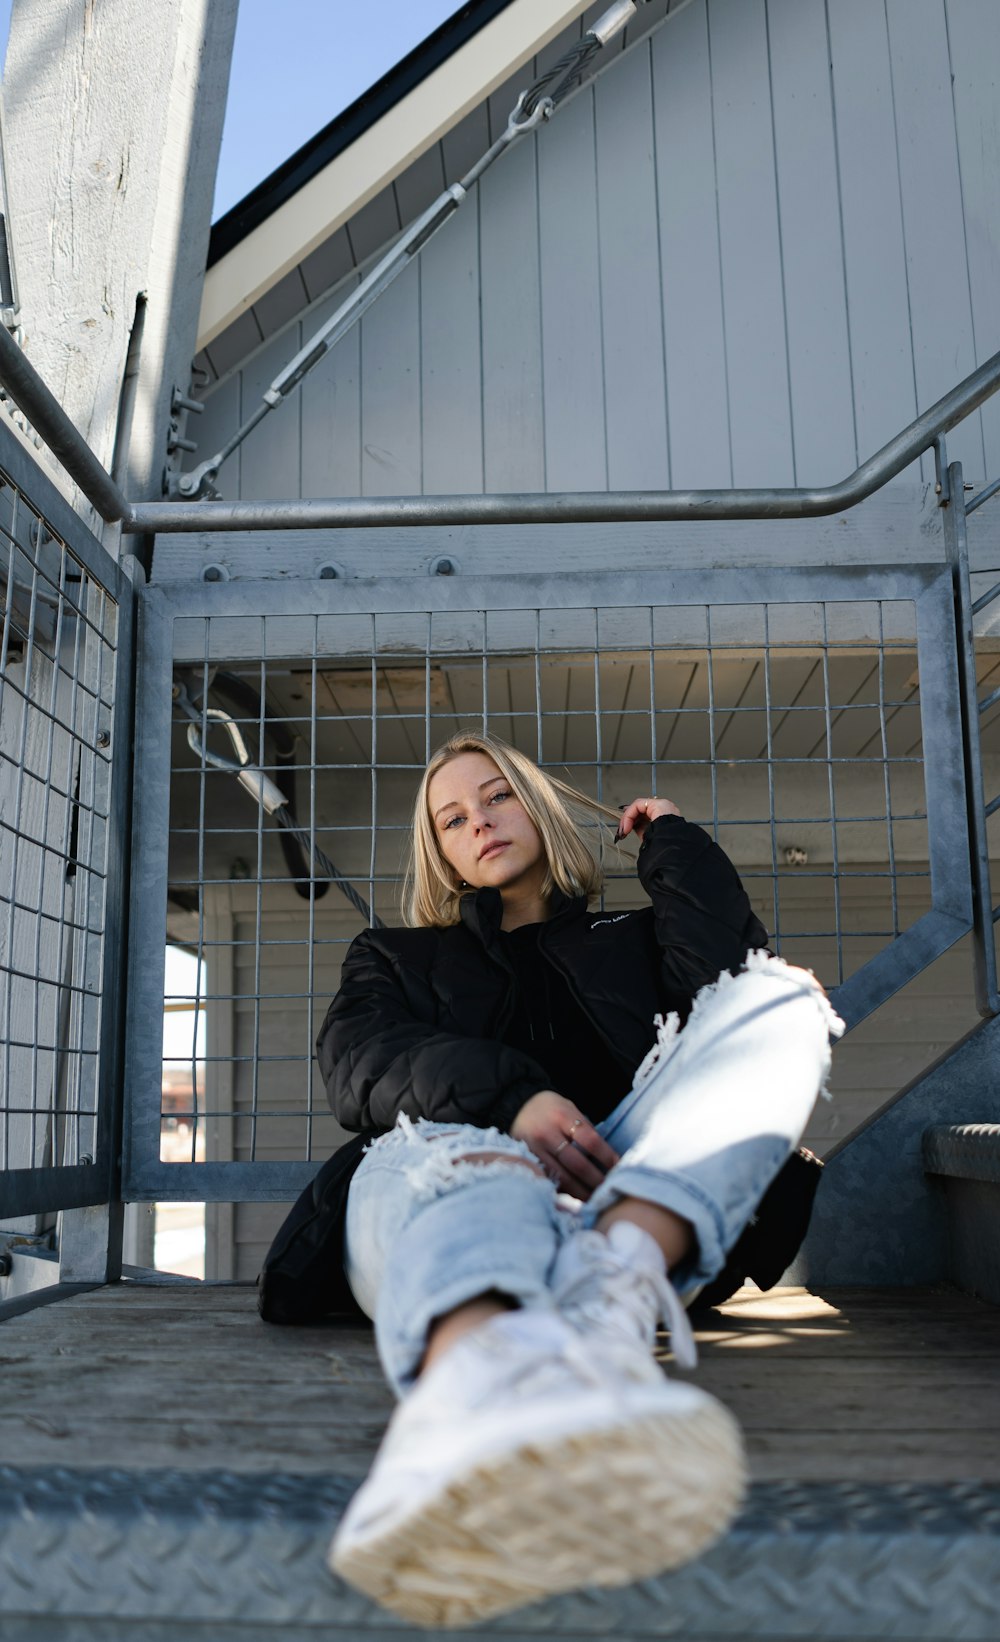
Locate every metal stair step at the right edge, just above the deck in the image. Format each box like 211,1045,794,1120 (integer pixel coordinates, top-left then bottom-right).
923,1123,1000,1305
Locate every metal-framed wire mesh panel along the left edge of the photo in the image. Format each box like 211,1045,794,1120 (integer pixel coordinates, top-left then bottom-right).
0,429,133,1220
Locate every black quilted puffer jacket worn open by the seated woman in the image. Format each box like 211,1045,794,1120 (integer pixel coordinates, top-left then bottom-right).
258,816,819,1323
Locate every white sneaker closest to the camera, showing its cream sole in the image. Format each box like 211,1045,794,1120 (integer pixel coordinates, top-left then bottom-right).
330,1310,745,1627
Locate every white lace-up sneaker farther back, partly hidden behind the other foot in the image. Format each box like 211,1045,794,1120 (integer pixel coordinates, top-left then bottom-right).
552,1220,698,1368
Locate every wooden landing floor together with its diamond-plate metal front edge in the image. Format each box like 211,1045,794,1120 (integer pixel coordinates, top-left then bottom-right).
0,1282,1000,1642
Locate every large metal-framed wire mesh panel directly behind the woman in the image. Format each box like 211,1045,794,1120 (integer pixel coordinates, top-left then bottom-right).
128,571,969,1199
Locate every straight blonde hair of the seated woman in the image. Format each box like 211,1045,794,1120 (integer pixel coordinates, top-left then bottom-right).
404,731,617,928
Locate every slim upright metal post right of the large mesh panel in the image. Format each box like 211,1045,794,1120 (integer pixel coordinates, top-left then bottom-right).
941,461,1000,1016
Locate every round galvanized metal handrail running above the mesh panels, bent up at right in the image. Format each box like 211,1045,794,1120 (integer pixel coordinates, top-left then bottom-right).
0,310,1000,535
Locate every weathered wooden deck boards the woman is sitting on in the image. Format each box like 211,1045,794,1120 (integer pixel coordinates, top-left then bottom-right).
0,1284,1000,1483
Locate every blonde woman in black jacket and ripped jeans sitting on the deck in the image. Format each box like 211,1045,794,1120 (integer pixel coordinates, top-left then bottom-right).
319,734,839,1626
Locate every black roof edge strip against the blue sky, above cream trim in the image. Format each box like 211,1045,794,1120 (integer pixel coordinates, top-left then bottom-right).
207,0,512,268
